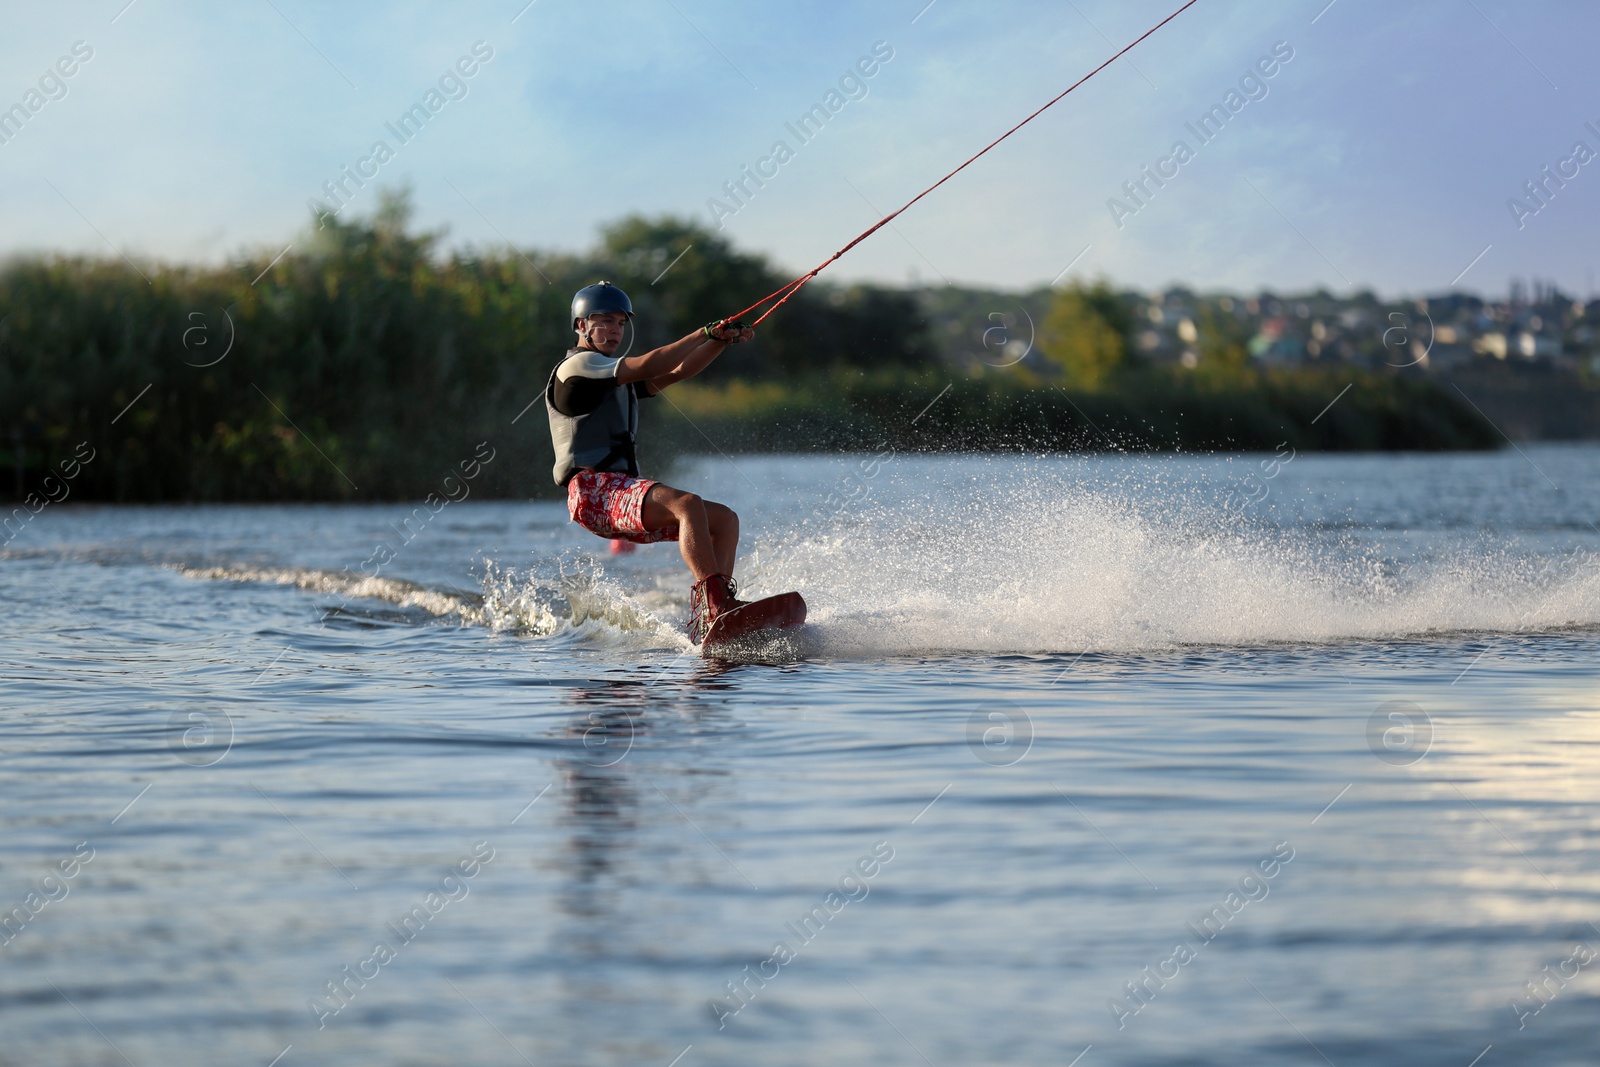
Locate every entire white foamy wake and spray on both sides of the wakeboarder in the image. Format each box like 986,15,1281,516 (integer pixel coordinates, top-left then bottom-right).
178,482,1600,659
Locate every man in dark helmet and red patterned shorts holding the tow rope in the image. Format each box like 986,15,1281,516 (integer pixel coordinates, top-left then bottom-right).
544,282,755,645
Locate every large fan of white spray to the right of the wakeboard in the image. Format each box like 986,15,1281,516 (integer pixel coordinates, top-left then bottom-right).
742,485,1600,656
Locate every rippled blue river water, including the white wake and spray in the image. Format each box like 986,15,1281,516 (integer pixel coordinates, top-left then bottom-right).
0,446,1600,1067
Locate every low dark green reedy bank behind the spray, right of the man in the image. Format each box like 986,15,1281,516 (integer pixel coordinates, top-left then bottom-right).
648,368,1501,453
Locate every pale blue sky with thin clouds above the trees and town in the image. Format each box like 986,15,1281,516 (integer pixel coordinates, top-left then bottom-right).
0,0,1600,296
